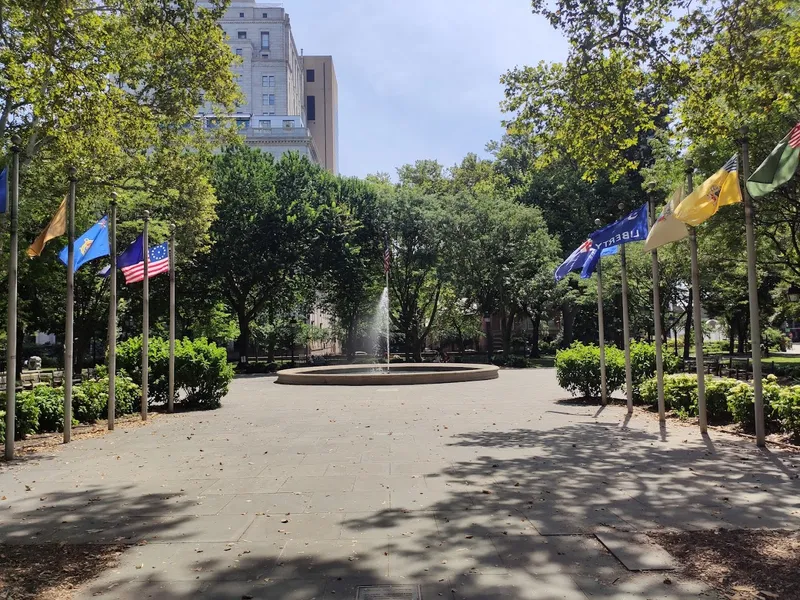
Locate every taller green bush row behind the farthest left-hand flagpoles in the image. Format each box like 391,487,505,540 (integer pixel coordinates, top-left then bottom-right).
117,336,234,409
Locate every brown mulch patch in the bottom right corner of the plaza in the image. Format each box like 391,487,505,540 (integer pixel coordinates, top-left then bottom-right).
648,530,800,600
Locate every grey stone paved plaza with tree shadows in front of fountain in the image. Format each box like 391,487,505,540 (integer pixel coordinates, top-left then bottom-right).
0,369,800,600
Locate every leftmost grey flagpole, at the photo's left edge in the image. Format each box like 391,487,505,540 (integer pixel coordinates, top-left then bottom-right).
5,135,22,460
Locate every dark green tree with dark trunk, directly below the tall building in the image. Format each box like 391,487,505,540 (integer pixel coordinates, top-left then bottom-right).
197,146,324,356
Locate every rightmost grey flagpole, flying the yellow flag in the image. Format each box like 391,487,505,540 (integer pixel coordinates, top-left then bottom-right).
740,126,766,446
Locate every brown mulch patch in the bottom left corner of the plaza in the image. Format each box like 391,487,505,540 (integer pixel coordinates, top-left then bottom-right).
0,544,126,600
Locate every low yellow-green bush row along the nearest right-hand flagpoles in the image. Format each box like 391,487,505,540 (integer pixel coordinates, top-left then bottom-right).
642,374,800,439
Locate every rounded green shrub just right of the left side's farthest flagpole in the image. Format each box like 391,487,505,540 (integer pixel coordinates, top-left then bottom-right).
175,338,234,408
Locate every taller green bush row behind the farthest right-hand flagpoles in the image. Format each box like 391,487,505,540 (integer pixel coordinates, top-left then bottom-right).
556,342,678,400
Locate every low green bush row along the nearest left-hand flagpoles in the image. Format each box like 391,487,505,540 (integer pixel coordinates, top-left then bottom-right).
0,375,141,441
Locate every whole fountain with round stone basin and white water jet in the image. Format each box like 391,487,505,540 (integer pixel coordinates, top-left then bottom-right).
277,273,499,385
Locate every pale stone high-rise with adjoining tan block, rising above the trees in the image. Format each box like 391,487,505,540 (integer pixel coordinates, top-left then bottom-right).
205,0,338,173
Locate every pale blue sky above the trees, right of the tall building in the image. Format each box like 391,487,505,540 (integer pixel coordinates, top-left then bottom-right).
283,0,567,178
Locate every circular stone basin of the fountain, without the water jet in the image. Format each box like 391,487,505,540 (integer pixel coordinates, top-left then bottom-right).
278,363,500,385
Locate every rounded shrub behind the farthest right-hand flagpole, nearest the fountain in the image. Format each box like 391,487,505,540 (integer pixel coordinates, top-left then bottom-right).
556,342,625,398
